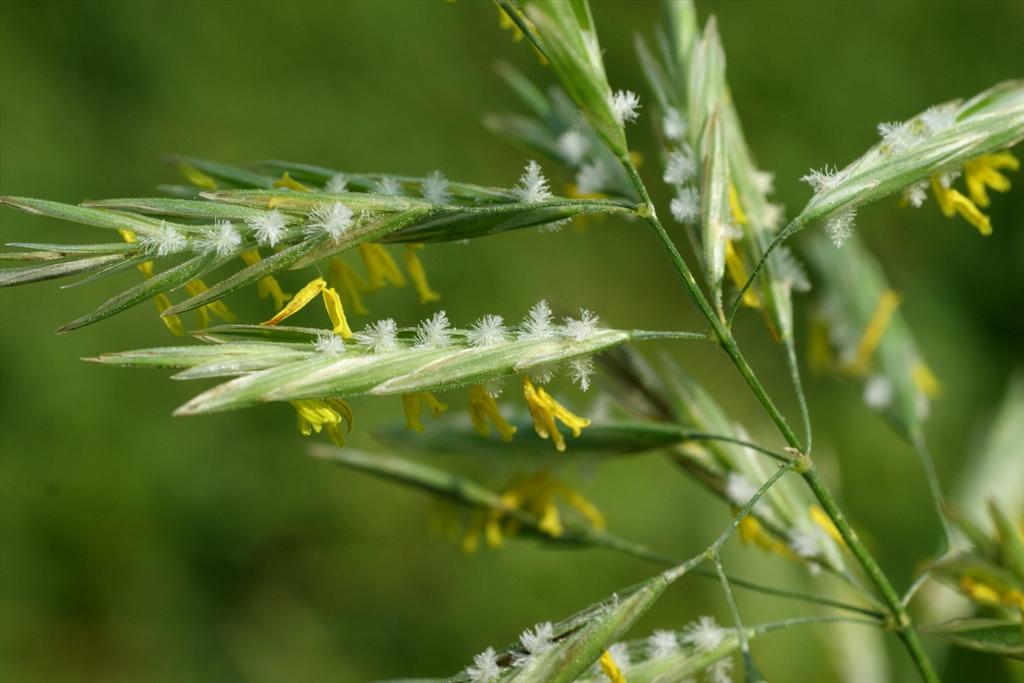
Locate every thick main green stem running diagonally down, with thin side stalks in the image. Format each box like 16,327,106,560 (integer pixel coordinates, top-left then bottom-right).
620,156,939,683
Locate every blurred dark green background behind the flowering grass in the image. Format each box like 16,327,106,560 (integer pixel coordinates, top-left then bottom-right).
0,1,1024,682
